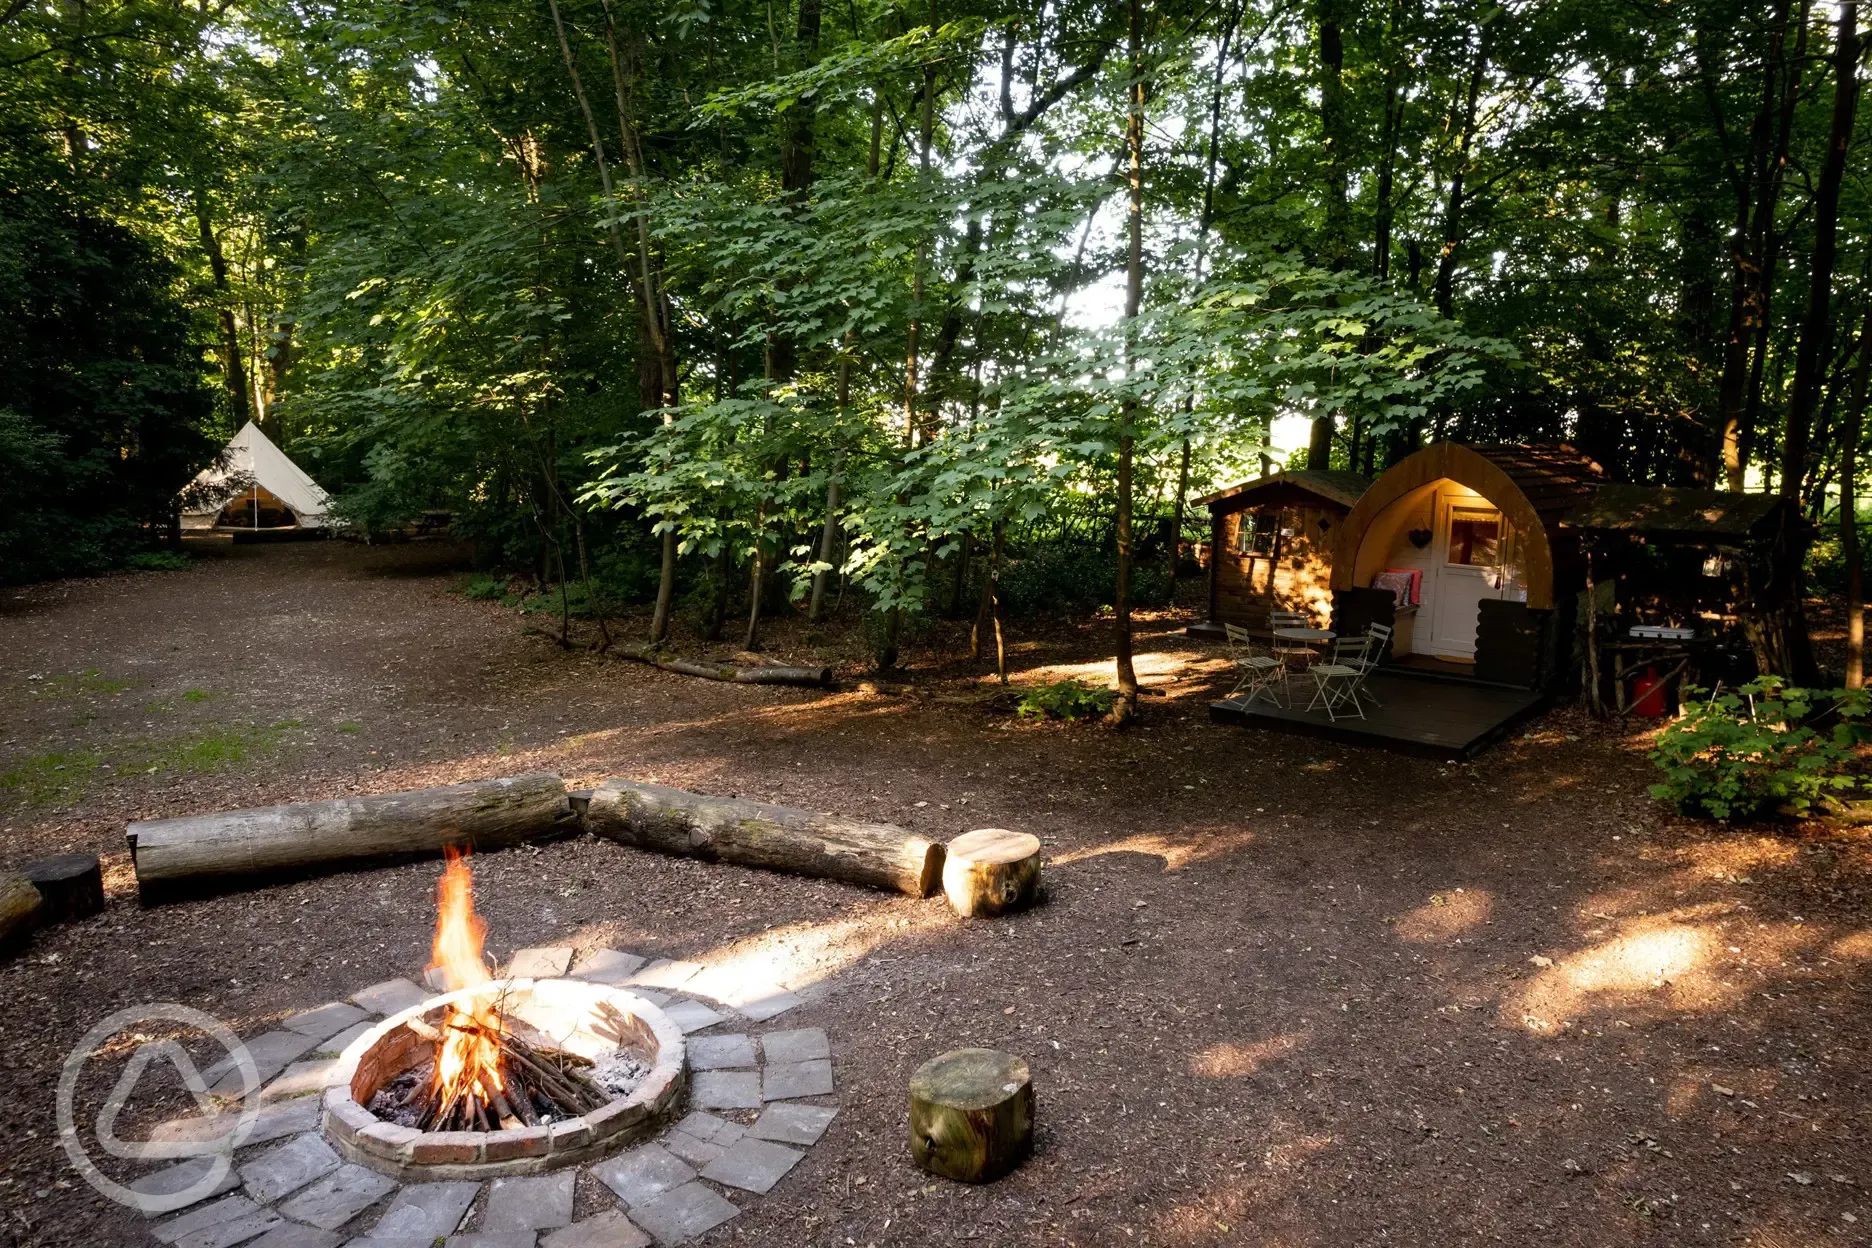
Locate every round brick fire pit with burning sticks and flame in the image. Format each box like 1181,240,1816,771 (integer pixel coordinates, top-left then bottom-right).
322,859,685,1179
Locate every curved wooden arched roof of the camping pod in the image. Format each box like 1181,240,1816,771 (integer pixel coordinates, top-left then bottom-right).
1333,442,1602,610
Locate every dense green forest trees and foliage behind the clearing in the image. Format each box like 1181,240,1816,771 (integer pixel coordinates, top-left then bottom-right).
0,0,1872,692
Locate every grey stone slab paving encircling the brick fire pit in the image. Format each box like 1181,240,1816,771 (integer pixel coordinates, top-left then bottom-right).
133,947,839,1248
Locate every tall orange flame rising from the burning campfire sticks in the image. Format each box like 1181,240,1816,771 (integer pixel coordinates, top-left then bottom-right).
429,849,505,1125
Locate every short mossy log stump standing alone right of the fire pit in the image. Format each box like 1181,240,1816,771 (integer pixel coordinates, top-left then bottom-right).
910,1048,1033,1183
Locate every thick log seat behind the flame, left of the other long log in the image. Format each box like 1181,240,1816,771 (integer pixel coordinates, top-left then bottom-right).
125,773,577,902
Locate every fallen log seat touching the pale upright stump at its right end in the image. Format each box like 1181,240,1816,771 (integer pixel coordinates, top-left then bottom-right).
584,780,943,896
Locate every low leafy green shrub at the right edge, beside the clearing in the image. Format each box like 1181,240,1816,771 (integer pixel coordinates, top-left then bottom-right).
1649,677,1872,820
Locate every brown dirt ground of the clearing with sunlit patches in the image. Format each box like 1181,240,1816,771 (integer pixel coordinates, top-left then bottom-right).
0,543,1872,1248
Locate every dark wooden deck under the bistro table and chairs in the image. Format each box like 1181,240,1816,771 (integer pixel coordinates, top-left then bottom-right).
1209,672,1546,758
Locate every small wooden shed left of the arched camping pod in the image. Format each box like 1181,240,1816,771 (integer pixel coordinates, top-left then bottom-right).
1191,470,1370,636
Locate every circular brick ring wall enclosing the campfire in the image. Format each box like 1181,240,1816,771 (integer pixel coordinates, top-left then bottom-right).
322,979,687,1181
